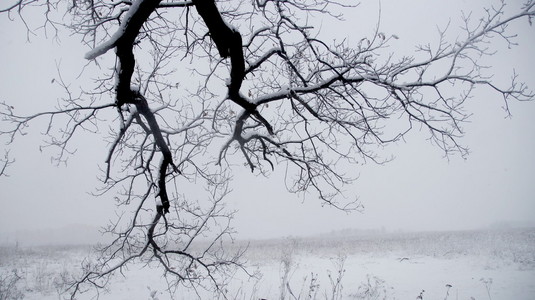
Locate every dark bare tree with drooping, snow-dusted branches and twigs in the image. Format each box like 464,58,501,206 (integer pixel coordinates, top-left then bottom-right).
0,0,535,297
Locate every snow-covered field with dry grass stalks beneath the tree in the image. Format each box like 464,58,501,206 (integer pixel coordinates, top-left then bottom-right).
0,229,535,300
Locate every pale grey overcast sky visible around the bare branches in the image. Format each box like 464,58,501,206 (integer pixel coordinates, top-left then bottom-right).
0,0,535,241
